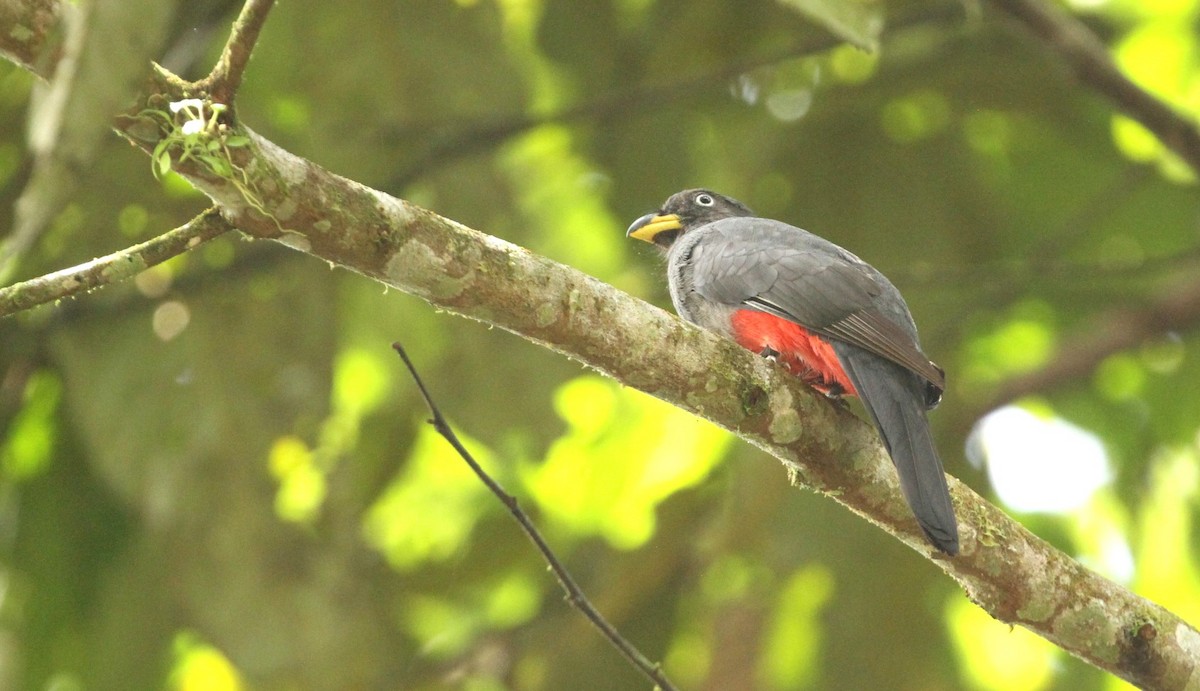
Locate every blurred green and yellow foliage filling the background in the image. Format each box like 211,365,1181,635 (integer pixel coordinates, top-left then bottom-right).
0,0,1200,690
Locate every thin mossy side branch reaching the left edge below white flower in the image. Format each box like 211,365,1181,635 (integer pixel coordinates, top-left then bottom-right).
0,208,233,318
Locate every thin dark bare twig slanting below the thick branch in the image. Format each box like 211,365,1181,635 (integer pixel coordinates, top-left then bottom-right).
391,343,676,691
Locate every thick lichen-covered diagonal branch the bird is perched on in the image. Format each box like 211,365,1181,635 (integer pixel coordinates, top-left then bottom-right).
100,94,1200,689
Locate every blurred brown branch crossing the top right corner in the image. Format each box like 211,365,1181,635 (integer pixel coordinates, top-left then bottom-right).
992,0,1200,174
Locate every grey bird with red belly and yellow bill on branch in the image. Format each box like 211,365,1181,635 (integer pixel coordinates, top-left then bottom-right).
628,190,959,554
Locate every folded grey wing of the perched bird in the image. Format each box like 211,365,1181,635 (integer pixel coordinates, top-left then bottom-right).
691,218,946,389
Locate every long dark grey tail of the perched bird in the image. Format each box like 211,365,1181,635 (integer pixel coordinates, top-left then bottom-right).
834,344,959,555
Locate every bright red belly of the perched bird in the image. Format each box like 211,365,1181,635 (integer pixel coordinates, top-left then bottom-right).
733,310,858,396
